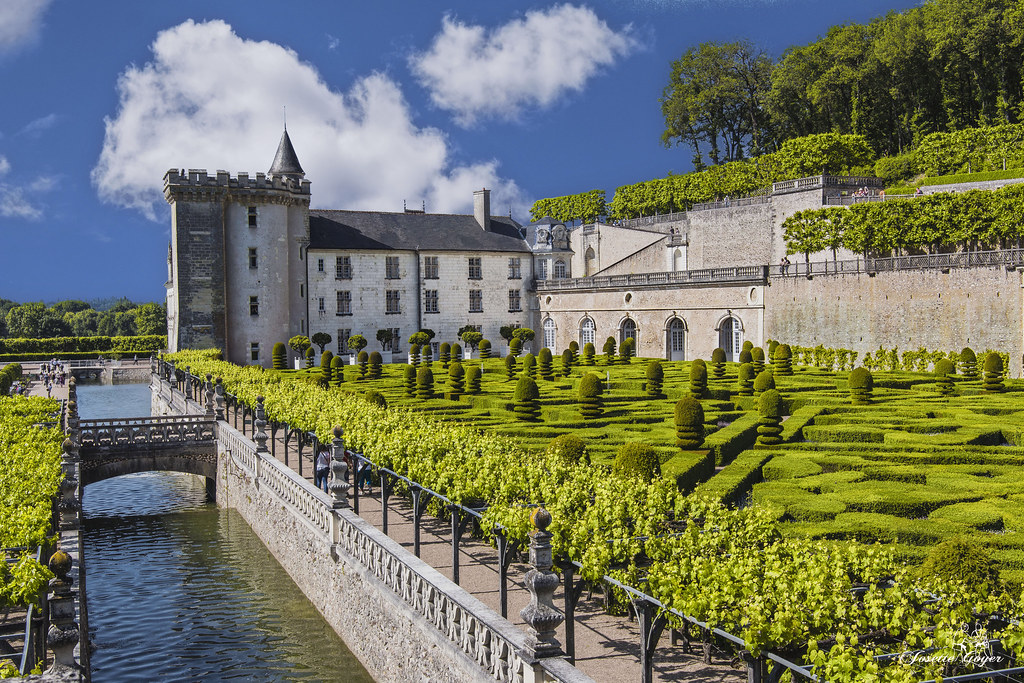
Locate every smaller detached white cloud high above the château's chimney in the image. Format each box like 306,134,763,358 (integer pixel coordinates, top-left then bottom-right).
410,4,639,126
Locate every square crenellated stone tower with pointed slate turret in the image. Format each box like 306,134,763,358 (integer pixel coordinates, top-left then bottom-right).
164,130,309,366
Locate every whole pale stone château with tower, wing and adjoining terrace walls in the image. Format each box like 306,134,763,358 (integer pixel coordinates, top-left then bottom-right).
164,131,1024,374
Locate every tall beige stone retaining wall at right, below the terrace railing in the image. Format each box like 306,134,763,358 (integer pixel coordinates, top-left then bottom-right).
765,267,1024,377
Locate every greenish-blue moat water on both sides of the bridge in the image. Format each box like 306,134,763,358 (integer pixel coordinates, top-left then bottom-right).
78,384,373,683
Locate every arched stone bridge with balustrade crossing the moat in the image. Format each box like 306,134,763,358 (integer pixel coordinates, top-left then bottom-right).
79,415,217,495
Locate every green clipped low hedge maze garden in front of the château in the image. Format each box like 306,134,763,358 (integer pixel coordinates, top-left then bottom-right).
264,348,1024,583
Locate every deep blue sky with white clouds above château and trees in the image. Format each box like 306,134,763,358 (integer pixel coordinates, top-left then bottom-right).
0,0,918,301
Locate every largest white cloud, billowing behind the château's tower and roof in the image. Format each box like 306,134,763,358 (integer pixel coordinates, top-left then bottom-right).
92,20,521,218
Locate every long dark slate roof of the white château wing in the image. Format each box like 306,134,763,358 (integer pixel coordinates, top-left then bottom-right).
309,209,529,253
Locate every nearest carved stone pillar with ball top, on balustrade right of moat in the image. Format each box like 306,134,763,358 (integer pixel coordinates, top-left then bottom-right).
519,508,565,659
